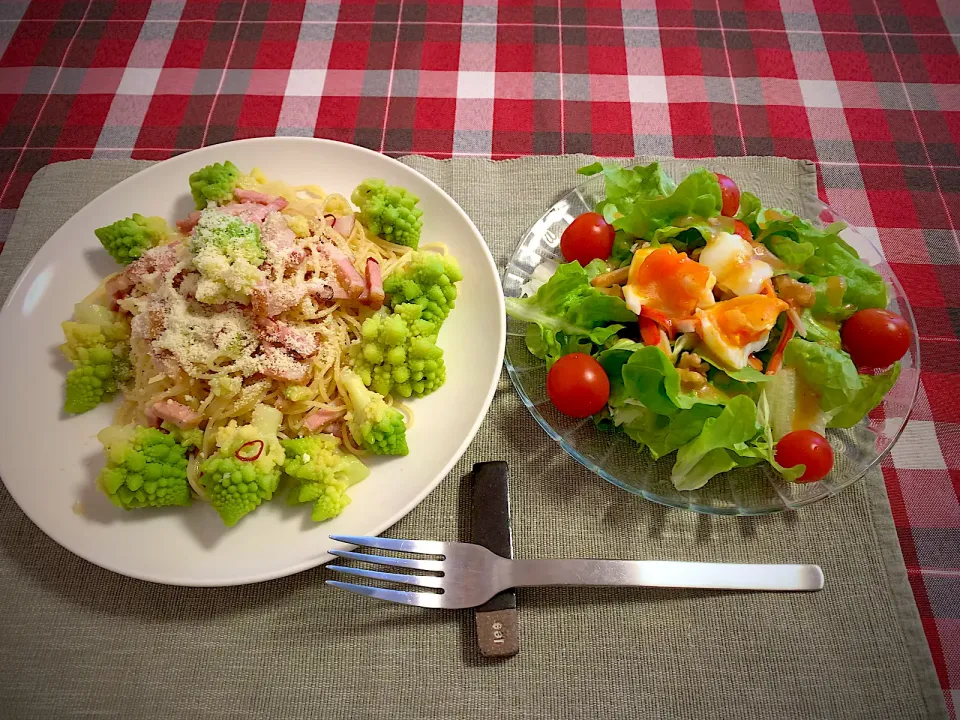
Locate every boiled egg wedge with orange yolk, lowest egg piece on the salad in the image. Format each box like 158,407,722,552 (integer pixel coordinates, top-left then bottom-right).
697,295,787,370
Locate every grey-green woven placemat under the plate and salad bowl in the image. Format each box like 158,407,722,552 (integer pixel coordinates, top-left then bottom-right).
0,157,946,720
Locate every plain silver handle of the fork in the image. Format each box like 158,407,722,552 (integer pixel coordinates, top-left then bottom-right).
509,560,823,591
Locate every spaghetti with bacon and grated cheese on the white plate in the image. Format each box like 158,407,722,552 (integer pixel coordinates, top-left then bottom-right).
109,170,413,462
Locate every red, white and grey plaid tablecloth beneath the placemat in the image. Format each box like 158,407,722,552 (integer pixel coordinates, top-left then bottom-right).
0,0,960,717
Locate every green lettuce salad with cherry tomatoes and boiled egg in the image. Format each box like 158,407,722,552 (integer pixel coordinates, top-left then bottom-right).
507,162,911,490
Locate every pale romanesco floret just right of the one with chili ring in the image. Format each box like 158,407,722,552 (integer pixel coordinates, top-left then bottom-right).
281,434,370,522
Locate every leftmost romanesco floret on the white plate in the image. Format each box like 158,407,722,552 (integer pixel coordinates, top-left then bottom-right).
60,303,132,414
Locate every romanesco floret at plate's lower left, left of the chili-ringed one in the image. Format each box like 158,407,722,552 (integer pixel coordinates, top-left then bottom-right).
97,425,191,510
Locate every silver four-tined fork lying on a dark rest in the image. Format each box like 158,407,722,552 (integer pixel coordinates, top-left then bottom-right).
327,535,823,608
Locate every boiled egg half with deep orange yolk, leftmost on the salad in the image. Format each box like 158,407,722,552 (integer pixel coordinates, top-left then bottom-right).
623,245,716,317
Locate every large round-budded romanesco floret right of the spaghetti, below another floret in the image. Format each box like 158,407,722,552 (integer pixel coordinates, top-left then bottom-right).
351,303,446,397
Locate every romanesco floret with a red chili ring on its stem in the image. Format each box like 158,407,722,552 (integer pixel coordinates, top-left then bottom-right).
200,405,285,527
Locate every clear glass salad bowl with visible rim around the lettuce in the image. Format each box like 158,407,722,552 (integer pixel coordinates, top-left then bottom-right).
503,176,920,515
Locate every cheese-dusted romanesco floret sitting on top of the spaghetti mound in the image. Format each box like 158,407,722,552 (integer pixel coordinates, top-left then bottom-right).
190,208,266,305
